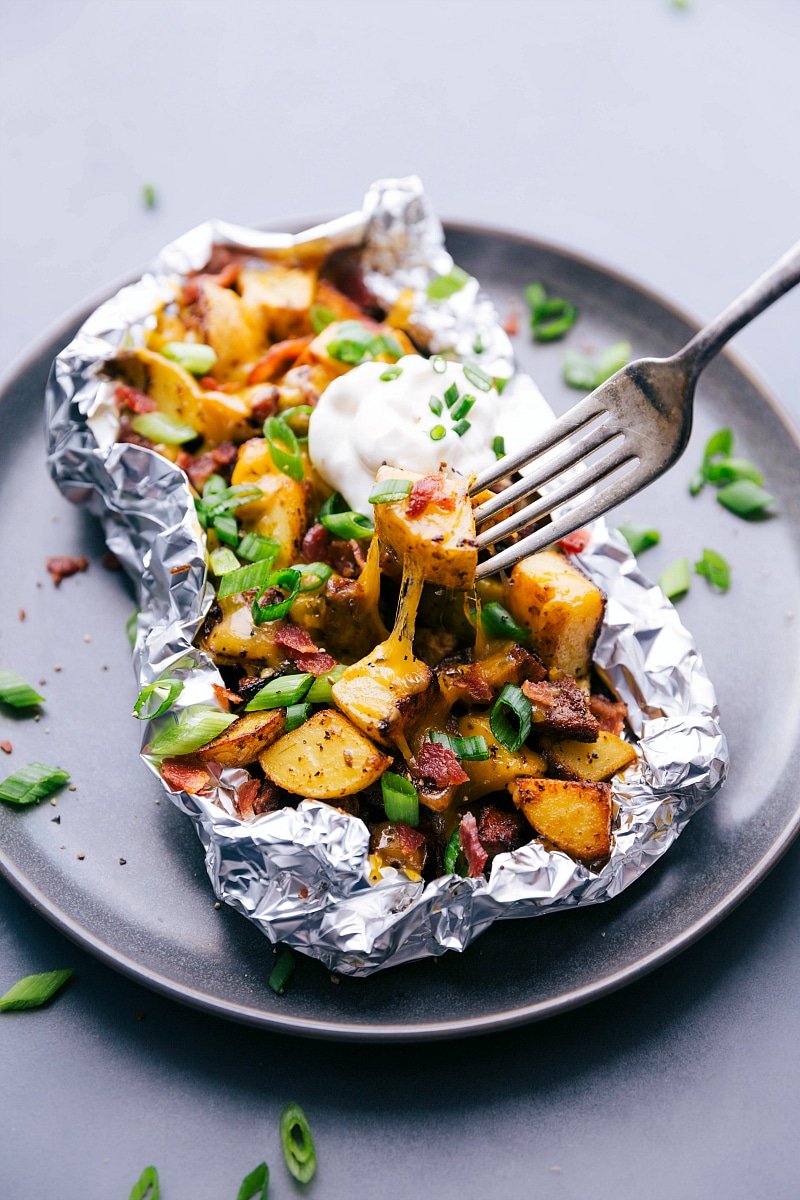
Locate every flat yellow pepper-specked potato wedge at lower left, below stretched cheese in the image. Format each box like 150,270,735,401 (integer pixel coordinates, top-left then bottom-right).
259,708,391,802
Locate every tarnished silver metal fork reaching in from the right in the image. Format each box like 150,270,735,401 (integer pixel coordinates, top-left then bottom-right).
471,242,800,578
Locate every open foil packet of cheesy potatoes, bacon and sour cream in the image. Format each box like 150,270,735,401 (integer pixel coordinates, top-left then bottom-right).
48,180,727,974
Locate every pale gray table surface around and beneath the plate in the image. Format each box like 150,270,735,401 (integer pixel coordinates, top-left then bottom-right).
0,0,800,1200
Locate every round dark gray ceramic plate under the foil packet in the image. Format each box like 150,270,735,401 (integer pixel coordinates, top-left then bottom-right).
0,226,800,1039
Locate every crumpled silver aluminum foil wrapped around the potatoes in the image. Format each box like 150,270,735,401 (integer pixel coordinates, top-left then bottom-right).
47,178,728,976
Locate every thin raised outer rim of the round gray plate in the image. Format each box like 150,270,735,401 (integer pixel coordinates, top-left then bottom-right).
0,223,800,1043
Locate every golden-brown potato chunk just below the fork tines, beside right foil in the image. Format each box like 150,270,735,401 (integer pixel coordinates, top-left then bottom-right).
507,550,606,678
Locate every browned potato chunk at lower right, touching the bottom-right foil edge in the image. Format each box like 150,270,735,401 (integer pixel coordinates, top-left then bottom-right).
511,779,612,863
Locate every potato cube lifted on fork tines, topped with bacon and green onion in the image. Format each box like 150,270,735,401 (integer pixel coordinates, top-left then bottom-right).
374,467,477,590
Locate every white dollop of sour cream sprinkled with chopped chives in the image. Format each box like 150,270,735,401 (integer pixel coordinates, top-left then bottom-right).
308,354,553,514
